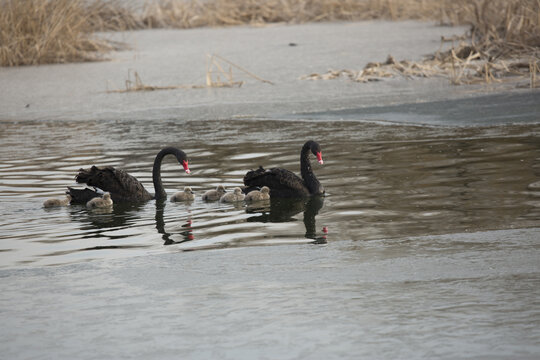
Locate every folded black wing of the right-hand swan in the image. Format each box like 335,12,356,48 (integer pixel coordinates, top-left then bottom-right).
244,167,310,198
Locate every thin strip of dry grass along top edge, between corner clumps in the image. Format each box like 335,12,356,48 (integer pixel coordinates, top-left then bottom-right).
141,0,443,28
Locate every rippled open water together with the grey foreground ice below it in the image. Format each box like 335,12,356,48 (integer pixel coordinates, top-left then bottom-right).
0,114,540,359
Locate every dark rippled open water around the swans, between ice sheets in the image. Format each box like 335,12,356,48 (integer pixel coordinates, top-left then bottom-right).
0,120,540,267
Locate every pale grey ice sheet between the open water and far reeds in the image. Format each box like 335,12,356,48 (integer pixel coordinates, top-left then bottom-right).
0,21,539,126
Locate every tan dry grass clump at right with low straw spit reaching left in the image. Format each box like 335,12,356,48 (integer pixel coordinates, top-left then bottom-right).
302,0,540,87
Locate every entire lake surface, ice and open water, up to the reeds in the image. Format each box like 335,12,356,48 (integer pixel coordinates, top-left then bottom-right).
0,21,540,360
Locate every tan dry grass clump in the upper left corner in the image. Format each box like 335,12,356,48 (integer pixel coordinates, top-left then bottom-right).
0,0,124,66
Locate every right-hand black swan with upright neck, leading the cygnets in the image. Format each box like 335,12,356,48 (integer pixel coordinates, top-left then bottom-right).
244,140,324,198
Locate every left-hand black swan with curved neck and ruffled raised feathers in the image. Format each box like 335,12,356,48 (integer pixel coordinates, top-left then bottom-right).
67,147,190,204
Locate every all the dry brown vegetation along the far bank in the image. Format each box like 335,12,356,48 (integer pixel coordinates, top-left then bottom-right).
0,0,540,86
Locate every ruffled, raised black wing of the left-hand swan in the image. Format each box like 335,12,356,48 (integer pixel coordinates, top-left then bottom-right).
75,166,153,202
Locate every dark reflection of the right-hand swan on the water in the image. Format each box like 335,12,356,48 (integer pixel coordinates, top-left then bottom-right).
246,196,328,244
